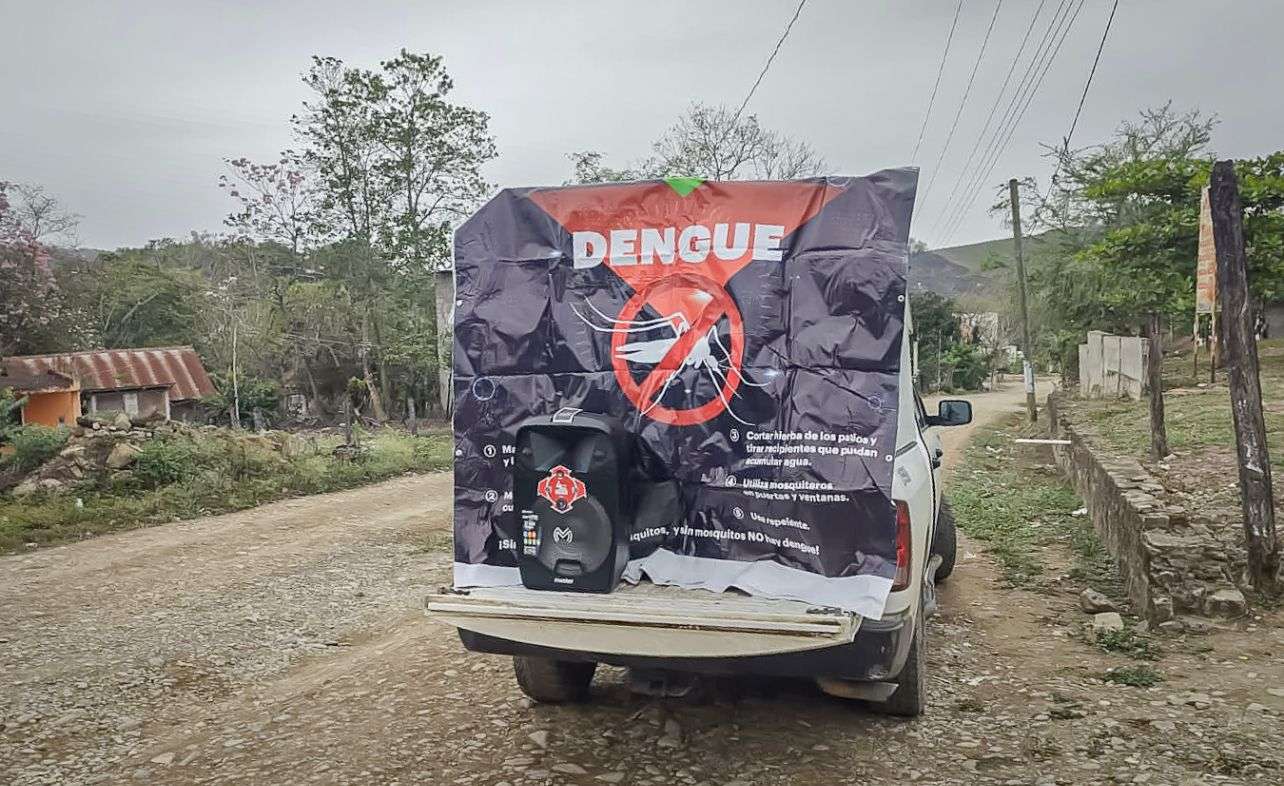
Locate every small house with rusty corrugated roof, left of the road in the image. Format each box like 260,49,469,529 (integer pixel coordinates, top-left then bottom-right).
0,347,214,423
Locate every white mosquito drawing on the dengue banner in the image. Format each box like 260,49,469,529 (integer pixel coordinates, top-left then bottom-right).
570,298,767,425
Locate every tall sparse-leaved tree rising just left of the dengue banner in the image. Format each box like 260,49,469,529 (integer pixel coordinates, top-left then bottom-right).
294,50,496,419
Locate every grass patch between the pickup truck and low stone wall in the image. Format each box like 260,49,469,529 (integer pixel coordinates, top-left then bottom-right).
948,415,1079,586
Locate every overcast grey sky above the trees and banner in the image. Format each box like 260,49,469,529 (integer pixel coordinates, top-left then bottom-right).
0,0,1284,248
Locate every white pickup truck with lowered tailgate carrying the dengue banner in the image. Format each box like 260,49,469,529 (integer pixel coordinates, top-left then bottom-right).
428,308,972,715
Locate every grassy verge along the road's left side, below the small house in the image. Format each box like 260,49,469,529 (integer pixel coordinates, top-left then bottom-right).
0,429,452,554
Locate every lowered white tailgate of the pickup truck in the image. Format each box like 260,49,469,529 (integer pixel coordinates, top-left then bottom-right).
428,582,860,658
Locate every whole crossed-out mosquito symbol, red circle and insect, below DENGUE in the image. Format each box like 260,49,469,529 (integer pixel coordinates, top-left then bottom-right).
573,274,765,425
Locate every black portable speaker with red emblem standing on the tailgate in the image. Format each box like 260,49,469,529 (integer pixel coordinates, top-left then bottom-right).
512,408,632,592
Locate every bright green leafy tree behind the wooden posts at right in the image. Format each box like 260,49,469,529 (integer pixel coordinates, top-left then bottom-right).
994,104,1284,351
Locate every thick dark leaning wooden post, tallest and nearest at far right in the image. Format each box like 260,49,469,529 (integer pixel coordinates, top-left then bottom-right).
1210,161,1280,593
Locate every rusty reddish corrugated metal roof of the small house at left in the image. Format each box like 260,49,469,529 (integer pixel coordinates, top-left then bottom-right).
4,347,214,401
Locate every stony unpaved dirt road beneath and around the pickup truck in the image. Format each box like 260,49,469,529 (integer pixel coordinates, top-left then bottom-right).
0,385,1284,786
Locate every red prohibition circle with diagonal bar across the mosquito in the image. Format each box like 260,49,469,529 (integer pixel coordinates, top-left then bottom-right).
611,274,745,425
